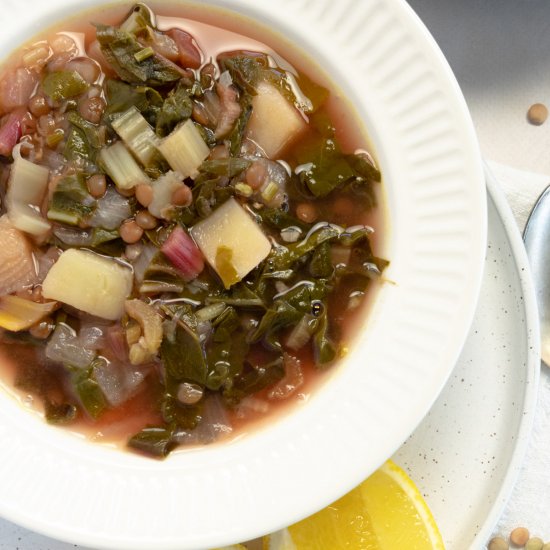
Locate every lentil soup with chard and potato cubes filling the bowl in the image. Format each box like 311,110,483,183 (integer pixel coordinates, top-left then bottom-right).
0,4,387,457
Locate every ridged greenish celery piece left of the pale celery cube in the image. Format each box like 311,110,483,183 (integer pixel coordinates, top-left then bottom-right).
112,106,159,166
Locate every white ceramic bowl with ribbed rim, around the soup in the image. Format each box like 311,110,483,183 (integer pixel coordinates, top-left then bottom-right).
0,0,486,550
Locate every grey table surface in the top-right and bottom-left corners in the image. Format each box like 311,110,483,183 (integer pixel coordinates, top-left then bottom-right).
4,0,550,550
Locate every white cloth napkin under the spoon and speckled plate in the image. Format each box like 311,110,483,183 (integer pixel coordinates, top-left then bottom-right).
488,162,550,542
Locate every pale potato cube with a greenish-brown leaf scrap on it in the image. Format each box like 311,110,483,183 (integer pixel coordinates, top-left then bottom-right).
190,199,271,288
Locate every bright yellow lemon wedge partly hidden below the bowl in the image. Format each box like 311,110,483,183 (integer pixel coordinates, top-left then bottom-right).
263,461,445,550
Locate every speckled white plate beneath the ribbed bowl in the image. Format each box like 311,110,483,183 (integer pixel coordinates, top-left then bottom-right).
395,171,540,550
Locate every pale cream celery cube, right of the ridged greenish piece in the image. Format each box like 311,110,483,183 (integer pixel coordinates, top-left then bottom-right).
158,119,210,178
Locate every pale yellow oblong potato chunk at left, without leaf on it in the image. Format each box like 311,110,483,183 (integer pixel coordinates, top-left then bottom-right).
42,248,133,321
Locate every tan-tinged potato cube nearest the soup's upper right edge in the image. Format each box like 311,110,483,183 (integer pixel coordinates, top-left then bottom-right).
246,82,307,159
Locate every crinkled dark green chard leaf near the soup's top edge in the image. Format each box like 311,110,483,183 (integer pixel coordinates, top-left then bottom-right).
95,23,184,86
